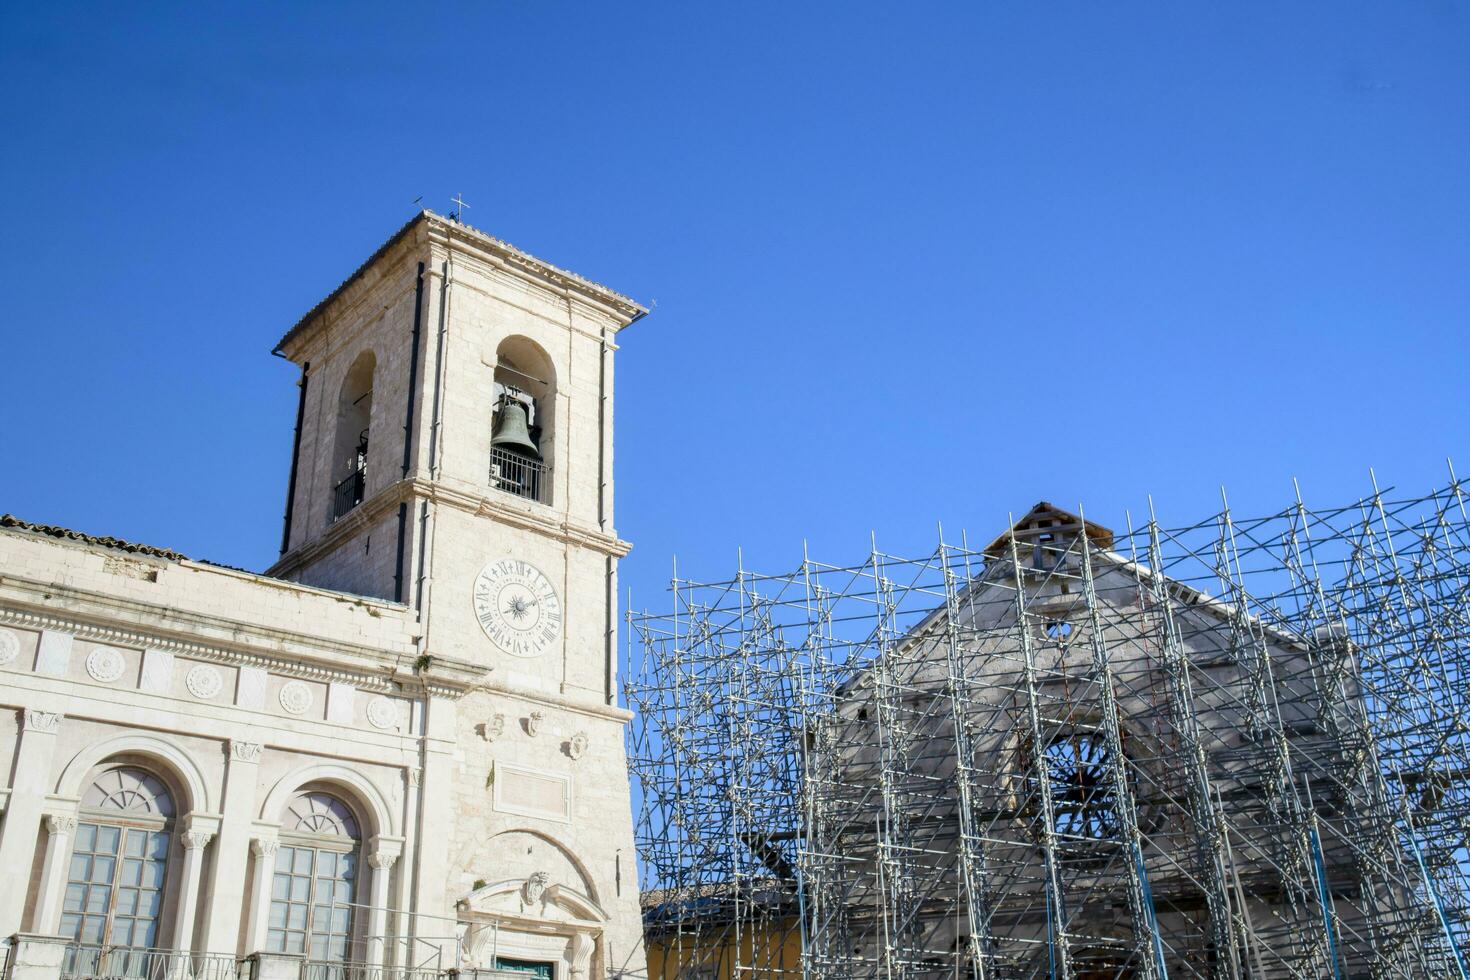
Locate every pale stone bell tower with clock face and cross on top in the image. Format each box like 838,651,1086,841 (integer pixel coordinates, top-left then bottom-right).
270,212,647,979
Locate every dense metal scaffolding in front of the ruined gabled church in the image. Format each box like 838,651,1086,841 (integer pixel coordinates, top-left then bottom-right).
625,473,1470,980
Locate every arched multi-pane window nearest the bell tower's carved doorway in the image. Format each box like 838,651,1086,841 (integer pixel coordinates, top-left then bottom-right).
266,790,362,964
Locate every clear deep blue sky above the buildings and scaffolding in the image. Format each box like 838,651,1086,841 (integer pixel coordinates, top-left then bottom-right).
0,0,1470,620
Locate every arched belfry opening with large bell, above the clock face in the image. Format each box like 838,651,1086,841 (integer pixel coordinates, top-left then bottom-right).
490,336,556,504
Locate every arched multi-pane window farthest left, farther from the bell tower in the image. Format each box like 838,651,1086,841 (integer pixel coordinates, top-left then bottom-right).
62,765,173,948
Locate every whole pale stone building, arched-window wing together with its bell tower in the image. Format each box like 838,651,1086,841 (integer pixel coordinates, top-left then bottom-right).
0,212,644,980
